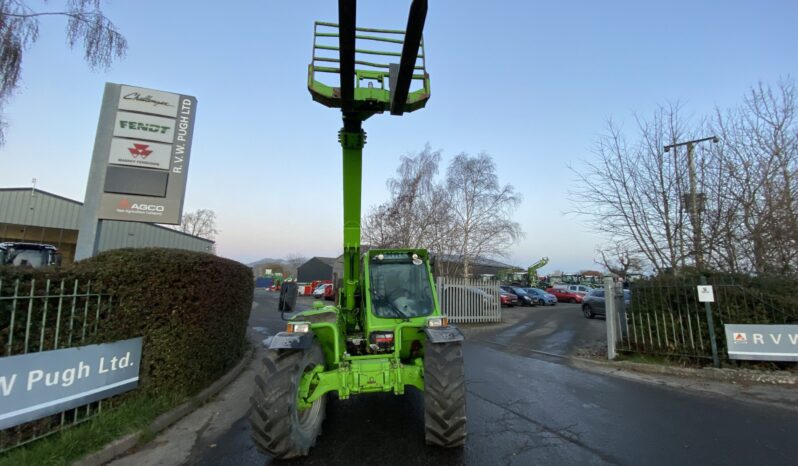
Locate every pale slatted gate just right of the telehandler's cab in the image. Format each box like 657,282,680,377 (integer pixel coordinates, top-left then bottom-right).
438,277,502,323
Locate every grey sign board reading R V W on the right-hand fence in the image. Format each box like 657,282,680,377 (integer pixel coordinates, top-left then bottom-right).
725,324,798,361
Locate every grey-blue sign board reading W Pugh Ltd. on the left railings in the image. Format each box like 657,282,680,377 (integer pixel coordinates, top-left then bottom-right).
0,337,141,429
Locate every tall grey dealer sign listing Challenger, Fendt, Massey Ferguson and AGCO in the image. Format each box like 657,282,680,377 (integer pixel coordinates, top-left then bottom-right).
75,83,197,260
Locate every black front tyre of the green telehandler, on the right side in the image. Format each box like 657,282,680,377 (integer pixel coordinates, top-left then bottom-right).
424,342,466,448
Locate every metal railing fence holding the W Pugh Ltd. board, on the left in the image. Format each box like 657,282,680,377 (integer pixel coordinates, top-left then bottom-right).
0,279,114,453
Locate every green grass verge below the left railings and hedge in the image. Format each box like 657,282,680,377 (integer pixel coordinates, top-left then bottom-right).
0,396,184,466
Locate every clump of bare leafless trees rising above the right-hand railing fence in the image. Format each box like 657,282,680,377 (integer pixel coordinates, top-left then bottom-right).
571,80,798,275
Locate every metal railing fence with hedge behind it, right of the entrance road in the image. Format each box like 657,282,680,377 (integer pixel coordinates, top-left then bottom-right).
616,277,798,360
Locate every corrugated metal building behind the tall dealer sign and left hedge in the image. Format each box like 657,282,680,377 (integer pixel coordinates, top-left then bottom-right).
0,188,214,263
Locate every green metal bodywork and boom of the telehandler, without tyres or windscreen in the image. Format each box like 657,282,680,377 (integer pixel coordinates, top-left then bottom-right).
292,10,441,409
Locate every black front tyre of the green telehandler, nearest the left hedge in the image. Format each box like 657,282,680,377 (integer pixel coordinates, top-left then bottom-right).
249,343,327,459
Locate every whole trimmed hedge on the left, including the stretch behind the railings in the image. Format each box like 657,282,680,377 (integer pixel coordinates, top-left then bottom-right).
0,248,253,396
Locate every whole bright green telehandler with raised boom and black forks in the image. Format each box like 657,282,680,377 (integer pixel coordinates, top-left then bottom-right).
250,0,466,458
